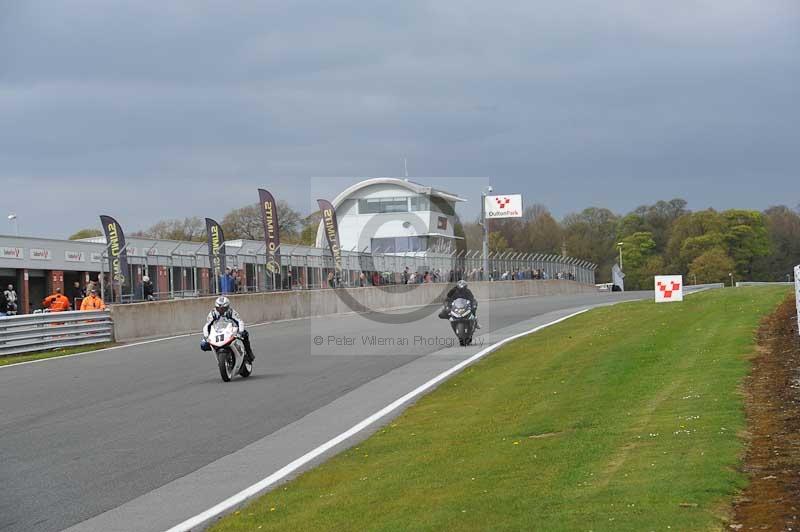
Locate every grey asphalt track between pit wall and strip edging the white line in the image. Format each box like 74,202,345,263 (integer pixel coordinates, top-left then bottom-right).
0,292,652,532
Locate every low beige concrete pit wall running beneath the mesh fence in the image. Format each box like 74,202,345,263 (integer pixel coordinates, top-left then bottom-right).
111,280,597,342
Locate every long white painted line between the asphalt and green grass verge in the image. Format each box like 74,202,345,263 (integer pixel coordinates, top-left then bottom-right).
162,308,589,532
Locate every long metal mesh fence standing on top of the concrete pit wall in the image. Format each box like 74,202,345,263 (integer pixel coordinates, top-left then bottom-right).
104,241,597,303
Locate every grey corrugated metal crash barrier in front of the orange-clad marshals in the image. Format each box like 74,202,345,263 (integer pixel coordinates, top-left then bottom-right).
0,310,114,356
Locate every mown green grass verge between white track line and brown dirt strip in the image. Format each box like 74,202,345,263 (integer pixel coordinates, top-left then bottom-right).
212,287,788,532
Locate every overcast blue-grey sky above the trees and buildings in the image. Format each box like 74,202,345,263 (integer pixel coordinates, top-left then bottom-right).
0,0,800,237
